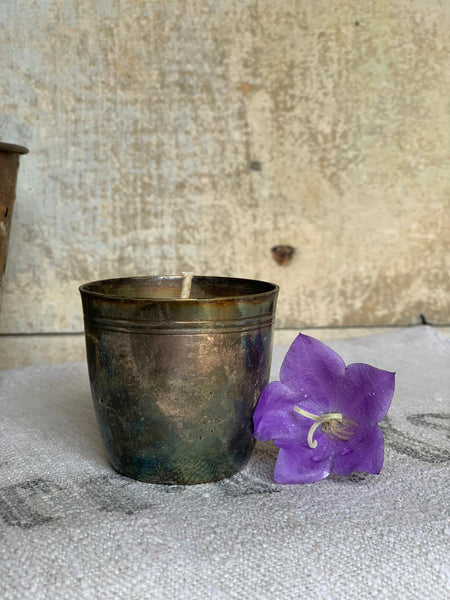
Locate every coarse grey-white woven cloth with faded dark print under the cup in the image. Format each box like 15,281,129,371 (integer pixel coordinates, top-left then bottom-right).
0,327,450,600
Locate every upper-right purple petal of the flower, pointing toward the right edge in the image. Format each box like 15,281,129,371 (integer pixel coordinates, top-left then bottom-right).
335,363,395,424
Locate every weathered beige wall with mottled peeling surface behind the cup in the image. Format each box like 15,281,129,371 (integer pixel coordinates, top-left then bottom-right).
0,0,450,332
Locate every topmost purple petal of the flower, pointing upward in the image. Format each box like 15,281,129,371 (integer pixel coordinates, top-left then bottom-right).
280,334,345,412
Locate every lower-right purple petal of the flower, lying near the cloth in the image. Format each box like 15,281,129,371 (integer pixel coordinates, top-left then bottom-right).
331,425,384,475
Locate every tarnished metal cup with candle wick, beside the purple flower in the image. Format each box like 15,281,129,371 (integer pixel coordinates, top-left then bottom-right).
80,277,278,484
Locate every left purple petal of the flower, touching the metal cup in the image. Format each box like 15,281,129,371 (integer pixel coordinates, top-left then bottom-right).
253,381,300,442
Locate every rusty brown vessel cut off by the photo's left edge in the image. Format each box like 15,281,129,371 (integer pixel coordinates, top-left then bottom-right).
0,142,28,305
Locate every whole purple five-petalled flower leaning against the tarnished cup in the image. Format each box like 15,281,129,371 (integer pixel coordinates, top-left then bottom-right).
253,334,395,483
